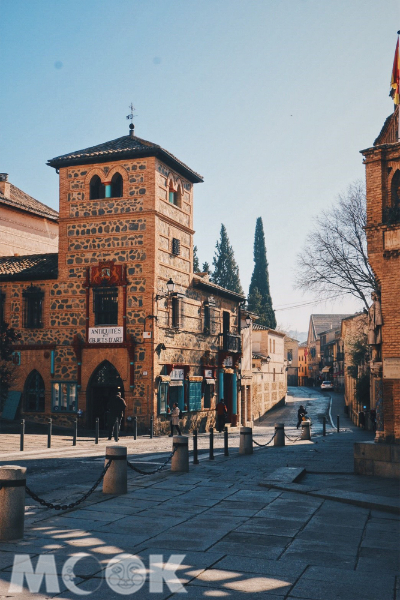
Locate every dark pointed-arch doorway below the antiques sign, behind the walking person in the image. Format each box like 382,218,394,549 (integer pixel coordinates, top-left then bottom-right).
86,360,125,429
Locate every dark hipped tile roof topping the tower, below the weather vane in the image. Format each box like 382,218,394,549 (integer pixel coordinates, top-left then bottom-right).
47,135,203,183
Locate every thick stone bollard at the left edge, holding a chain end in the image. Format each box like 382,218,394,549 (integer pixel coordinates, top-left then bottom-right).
0,465,26,542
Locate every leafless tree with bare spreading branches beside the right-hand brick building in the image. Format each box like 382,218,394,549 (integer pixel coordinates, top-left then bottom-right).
296,182,378,309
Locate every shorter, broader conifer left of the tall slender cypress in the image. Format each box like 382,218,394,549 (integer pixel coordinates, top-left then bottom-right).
211,224,243,294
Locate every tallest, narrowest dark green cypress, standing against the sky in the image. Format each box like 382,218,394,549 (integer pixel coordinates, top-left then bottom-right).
247,217,276,329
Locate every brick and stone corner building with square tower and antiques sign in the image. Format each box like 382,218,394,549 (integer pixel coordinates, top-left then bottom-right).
0,126,244,430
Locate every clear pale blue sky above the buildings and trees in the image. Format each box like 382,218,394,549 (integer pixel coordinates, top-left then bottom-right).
0,0,400,330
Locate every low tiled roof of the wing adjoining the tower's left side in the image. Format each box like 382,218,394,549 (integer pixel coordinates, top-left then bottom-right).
0,253,58,281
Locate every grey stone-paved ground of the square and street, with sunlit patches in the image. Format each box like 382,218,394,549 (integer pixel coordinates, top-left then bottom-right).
0,388,400,600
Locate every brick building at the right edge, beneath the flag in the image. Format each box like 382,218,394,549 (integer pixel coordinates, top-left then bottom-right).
362,106,400,452
